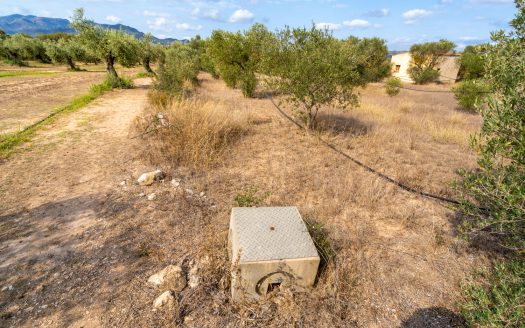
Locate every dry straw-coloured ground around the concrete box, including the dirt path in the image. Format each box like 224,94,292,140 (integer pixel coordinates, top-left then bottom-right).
0,68,491,327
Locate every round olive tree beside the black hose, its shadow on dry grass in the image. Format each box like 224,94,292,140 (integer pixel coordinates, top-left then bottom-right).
264,25,366,129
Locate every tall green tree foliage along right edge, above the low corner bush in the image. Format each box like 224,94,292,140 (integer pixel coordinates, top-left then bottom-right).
457,0,525,251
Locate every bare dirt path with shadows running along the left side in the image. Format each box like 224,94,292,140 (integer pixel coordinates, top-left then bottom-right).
0,79,154,325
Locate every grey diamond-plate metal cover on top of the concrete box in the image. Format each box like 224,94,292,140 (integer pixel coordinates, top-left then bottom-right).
230,207,318,262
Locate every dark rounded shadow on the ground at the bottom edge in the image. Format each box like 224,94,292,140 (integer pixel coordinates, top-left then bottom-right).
401,307,468,328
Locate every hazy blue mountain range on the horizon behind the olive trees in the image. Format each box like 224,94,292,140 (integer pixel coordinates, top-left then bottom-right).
0,14,187,44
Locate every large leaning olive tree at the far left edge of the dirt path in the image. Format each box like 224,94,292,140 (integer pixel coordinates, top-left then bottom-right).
71,9,140,79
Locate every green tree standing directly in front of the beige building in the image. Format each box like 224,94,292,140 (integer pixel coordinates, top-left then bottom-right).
408,40,456,84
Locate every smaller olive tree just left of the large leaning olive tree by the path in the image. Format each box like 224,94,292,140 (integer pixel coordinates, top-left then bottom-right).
44,37,87,71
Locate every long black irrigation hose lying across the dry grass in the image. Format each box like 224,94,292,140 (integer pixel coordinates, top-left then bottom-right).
270,96,461,205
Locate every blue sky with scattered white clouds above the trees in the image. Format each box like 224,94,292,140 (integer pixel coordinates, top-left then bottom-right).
0,0,516,50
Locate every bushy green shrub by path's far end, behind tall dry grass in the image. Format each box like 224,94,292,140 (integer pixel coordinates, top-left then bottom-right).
155,43,199,96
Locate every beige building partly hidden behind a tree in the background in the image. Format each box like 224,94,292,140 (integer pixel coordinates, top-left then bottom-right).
392,52,459,83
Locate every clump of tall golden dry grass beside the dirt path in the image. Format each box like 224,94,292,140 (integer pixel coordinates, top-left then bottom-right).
139,92,250,168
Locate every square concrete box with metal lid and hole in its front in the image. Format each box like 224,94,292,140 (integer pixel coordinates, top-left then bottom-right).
228,207,320,301
